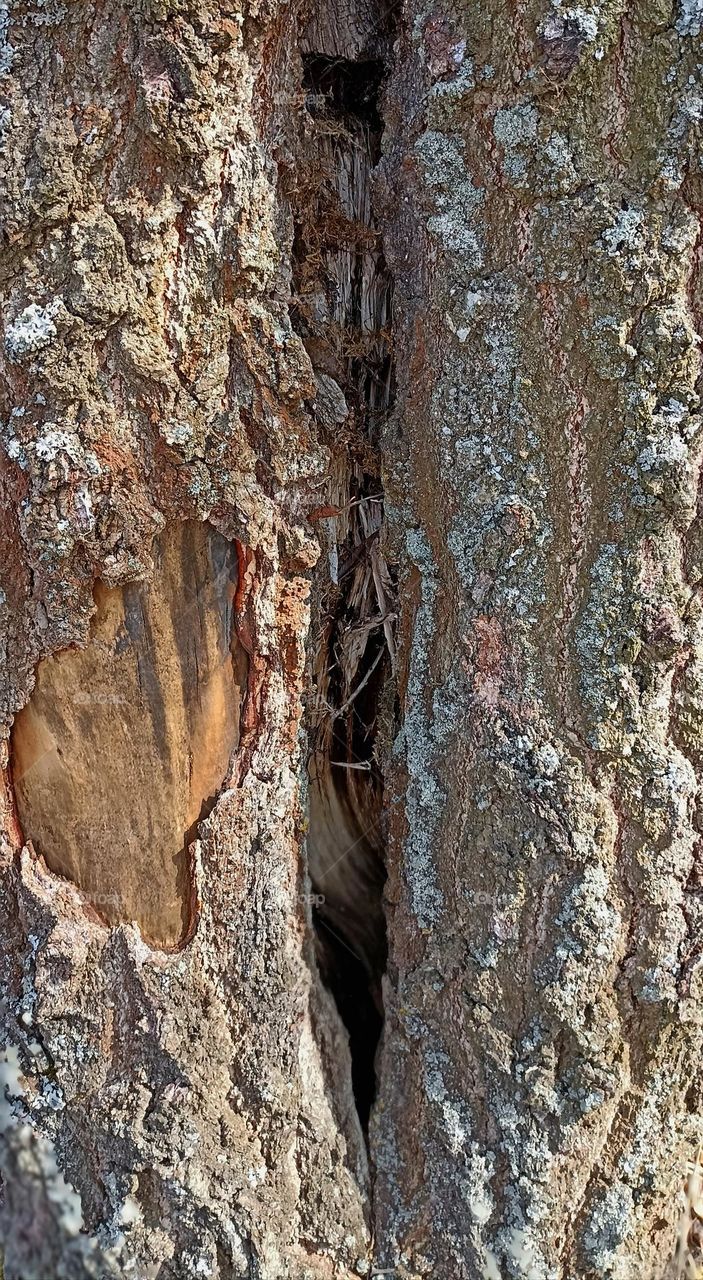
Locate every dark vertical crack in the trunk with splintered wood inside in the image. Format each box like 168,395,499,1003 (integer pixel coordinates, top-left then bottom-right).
293,10,394,1129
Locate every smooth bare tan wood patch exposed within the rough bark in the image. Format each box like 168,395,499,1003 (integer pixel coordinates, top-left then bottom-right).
12,522,246,947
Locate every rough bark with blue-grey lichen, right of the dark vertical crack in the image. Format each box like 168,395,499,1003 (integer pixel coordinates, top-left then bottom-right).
374,0,703,1280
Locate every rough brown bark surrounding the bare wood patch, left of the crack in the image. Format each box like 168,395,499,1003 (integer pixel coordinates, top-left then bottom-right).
1,3,368,1280
